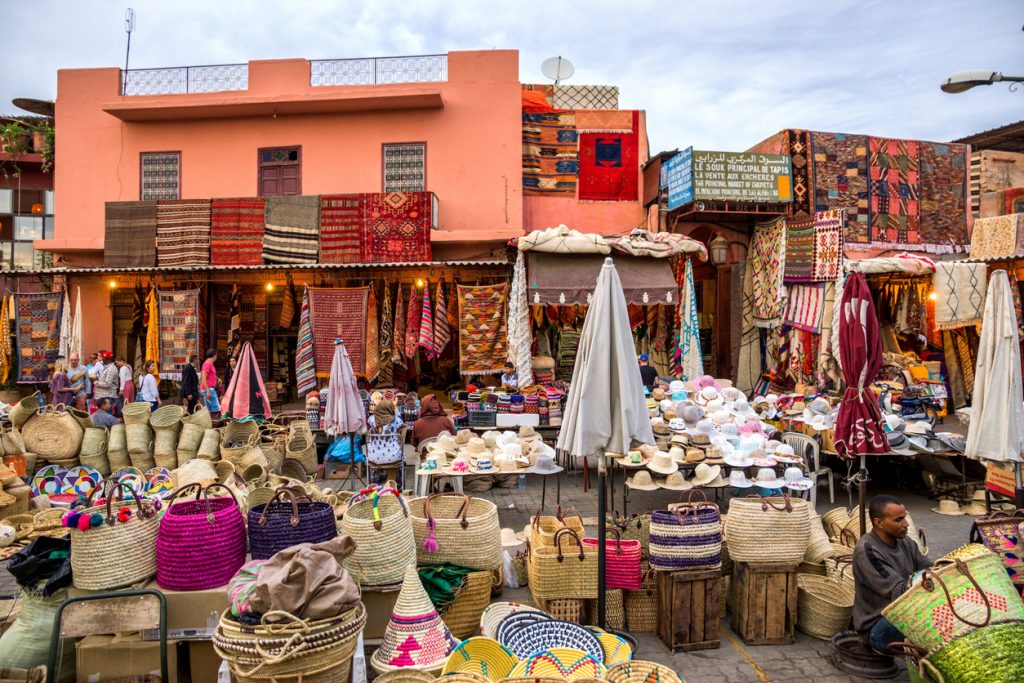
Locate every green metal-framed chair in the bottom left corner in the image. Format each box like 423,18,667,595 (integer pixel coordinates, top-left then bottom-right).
46,588,170,683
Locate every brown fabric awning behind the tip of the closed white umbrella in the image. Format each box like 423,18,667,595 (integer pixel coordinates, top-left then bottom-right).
526,252,679,305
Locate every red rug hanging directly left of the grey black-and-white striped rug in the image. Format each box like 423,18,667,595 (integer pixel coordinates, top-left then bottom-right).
210,197,266,265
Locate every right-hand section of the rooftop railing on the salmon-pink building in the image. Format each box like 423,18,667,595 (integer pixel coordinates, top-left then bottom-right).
309,54,447,86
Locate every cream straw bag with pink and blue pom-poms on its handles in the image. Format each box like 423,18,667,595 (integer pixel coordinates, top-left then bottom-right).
71,483,160,591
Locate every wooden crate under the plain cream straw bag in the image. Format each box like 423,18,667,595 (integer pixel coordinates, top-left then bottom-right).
732,562,798,645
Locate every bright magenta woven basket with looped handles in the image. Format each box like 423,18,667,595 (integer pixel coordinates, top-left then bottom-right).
157,483,246,591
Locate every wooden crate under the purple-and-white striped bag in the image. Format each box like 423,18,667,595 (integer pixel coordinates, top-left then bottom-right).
657,569,722,652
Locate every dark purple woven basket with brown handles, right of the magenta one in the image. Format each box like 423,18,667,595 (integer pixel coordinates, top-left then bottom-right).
248,487,338,560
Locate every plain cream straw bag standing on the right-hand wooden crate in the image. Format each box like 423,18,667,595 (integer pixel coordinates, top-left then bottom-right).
728,496,810,564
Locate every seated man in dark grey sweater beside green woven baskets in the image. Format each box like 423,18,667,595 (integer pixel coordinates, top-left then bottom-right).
853,496,932,654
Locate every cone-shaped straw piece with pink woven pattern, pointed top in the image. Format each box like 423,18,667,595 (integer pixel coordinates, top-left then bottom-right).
370,566,459,674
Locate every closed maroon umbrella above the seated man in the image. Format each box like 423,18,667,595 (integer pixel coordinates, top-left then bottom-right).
836,272,889,459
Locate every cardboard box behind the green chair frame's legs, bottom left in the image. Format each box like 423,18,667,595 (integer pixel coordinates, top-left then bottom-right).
75,636,178,683
